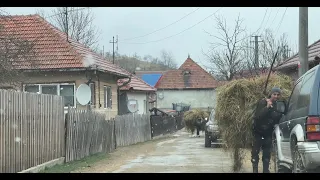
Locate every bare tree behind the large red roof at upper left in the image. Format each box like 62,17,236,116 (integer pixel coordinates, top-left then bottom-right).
42,7,100,51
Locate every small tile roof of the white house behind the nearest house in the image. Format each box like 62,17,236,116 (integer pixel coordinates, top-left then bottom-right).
118,69,157,91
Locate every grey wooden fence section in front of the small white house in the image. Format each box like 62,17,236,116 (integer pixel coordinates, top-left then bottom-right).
115,114,151,146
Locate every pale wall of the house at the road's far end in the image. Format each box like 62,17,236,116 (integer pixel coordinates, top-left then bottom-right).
157,89,216,109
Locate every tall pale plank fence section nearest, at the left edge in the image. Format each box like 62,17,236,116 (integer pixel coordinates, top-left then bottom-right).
0,90,65,173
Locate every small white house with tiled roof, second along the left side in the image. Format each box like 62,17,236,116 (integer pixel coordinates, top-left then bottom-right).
118,73,157,115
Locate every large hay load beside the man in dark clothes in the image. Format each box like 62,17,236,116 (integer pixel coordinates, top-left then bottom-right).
215,74,292,172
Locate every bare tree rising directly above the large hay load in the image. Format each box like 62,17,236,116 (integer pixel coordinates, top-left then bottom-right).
205,16,245,80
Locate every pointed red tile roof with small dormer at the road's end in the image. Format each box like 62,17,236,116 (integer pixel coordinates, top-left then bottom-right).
155,57,218,89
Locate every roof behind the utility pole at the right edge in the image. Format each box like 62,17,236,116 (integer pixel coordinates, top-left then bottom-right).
275,40,320,70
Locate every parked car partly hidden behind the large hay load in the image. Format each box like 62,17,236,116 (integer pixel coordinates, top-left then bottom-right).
204,109,222,147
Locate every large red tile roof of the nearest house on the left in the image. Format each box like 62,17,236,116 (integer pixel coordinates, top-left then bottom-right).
0,15,127,77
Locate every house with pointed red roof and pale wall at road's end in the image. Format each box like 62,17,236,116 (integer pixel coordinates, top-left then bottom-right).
155,56,218,110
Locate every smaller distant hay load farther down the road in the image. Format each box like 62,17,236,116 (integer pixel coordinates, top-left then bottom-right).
183,109,209,134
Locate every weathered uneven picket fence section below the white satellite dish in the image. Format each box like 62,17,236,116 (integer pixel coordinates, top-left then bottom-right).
65,109,115,162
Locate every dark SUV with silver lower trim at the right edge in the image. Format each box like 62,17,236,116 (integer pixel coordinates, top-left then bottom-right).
273,65,320,173
